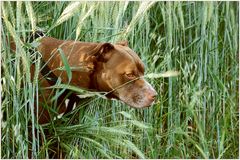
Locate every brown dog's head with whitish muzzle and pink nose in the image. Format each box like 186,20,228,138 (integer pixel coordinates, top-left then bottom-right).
94,42,157,108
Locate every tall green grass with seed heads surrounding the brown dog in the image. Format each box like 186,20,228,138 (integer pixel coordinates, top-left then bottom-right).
1,2,239,158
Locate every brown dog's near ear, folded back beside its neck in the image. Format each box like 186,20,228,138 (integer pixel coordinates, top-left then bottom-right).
93,43,114,62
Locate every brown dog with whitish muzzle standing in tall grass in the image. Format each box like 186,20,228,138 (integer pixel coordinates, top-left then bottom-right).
24,37,157,123
